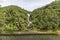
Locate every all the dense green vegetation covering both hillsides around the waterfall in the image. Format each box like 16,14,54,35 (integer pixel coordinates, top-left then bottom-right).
0,1,60,32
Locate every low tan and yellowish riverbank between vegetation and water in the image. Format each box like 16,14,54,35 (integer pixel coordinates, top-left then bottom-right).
0,30,60,35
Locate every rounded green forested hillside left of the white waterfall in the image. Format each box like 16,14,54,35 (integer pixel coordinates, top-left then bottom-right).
0,5,30,31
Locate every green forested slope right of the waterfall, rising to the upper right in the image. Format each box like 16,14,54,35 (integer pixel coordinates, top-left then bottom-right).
32,1,60,30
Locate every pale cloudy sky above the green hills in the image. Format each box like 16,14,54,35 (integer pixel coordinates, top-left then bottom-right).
0,0,54,11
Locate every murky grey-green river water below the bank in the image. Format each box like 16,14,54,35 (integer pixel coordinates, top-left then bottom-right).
0,35,60,40
